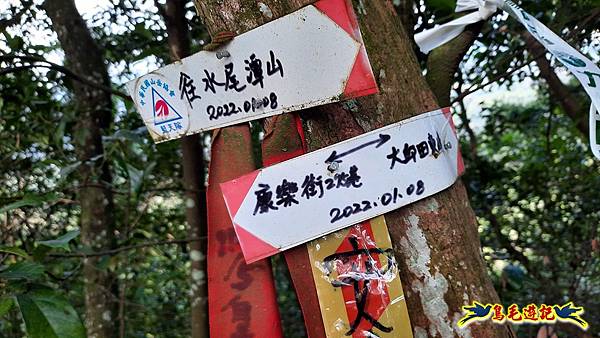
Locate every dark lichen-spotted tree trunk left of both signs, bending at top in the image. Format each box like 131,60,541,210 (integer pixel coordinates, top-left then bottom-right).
43,0,118,338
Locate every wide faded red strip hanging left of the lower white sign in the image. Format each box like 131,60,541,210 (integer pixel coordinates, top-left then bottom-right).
206,125,283,338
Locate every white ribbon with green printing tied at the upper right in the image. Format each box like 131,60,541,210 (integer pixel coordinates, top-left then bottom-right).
415,0,600,159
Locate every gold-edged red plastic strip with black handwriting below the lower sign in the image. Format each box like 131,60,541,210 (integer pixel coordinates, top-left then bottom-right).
308,217,412,337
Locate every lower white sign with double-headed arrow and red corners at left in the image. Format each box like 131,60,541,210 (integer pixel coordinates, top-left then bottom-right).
221,109,464,263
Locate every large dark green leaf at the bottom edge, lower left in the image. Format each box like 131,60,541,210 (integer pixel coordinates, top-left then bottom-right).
17,289,85,338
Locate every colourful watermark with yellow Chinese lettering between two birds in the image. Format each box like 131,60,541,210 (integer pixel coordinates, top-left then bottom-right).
458,302,589,330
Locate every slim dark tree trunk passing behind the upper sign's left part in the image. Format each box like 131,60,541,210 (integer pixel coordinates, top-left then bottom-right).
161,0,208,338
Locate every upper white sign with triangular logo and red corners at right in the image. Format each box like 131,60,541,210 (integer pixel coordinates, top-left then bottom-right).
127,0,377,142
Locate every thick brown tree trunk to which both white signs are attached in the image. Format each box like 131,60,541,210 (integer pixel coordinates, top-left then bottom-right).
196,0,513,338
